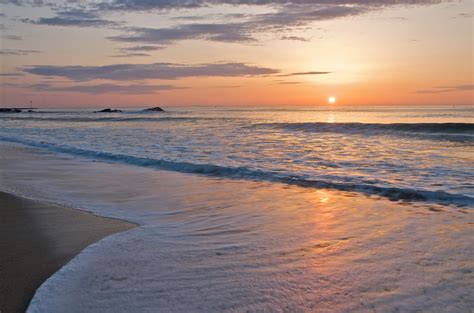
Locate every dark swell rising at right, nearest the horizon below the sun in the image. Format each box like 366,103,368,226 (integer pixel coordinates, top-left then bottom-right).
255,122,474,141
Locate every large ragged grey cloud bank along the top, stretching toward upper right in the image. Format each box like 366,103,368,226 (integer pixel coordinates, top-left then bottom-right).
108,0,440,45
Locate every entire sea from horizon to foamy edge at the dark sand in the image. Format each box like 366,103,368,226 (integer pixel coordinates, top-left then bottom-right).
0,106,474,312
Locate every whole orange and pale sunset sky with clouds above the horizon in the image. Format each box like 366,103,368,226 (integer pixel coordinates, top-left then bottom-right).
0,0,474,107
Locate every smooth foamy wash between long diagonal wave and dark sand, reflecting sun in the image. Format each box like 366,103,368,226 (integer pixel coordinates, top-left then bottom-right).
0,140,474,313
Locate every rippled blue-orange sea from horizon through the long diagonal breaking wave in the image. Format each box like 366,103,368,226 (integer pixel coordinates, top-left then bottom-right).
0,106,474,206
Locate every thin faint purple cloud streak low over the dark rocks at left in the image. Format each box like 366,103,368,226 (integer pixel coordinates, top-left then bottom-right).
22,83,184,94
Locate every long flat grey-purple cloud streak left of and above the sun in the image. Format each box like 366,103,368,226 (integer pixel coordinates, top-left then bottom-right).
20,63,278,81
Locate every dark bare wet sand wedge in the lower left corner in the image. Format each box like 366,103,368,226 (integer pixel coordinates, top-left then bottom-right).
0,192,134,313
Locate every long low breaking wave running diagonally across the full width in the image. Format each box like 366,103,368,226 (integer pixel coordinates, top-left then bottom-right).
0,136,474,206
